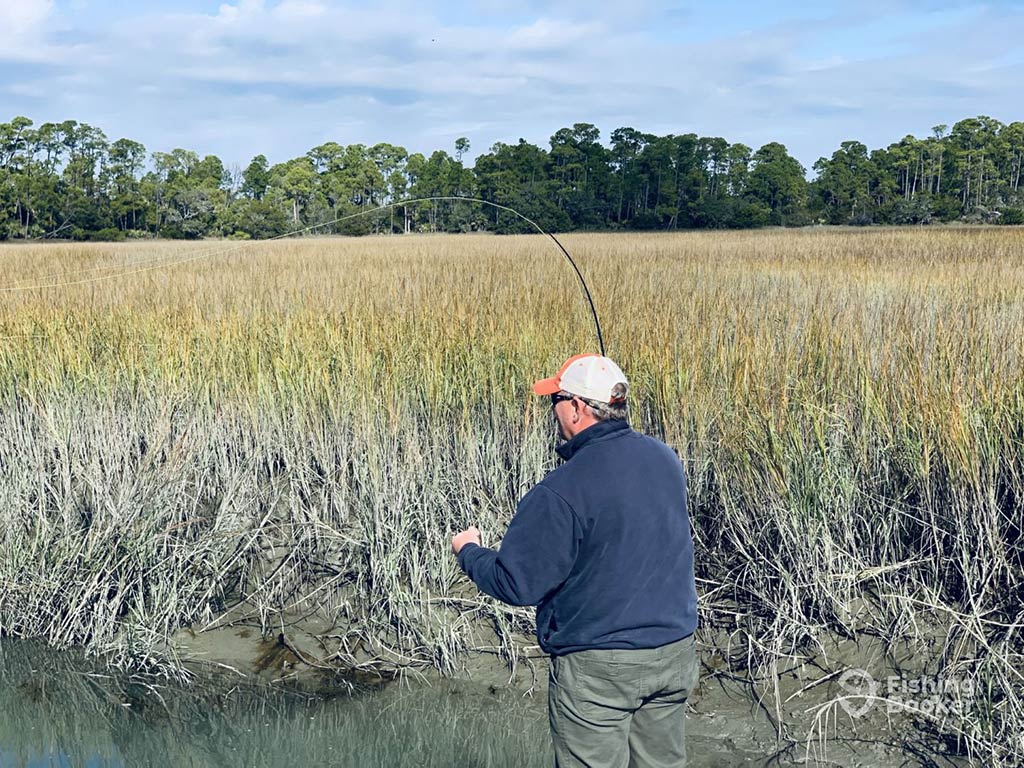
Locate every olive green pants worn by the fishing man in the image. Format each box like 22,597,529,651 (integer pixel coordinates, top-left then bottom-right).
548,635,698,768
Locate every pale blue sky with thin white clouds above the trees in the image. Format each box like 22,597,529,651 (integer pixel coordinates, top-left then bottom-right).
0,0,1024,168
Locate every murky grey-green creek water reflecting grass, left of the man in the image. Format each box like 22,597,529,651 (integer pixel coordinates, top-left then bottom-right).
0,641,553,768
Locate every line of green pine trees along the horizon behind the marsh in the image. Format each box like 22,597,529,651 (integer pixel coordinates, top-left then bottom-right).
0,116,1024,240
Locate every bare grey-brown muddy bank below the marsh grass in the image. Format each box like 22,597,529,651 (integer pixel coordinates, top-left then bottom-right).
165,617,966,768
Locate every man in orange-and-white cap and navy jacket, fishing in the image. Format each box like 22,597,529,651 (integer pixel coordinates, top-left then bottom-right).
452,354,698,768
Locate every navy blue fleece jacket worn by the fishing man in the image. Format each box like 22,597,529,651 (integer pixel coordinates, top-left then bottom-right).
459,421,697,655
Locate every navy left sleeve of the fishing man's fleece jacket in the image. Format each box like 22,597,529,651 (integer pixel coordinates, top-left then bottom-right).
459,485,582,605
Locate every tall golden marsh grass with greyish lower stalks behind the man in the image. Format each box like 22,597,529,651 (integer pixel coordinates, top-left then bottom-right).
0,229,1024,760
